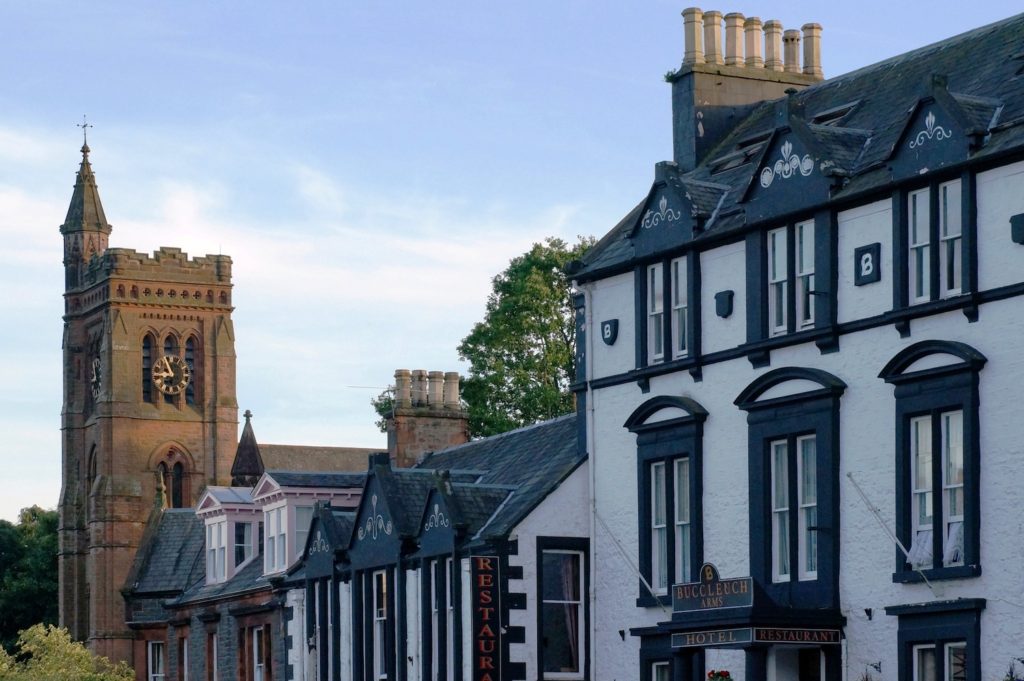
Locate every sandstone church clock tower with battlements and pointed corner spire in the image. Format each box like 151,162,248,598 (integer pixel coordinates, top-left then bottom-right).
59,144,238,662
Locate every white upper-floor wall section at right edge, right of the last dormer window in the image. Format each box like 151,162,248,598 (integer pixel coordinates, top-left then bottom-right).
978,162,1024,291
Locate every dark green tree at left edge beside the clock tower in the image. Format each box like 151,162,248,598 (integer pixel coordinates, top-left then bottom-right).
0,506,57,650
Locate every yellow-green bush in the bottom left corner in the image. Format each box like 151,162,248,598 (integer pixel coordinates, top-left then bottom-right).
0,624,135,681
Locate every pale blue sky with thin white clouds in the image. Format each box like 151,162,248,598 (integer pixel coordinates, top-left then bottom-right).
0,0,1008,519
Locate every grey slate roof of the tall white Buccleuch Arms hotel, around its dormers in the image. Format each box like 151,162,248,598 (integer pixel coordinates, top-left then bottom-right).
572,14,1024,281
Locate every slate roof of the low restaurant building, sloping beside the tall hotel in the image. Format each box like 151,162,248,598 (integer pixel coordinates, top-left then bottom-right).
418,415,587,539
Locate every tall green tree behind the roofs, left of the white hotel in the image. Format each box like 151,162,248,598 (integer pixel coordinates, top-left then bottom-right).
459,238,594,436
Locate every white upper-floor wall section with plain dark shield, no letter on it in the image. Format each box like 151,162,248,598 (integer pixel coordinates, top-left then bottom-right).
700,242,746,353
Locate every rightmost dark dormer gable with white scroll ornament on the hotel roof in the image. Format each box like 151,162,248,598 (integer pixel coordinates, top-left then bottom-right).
888,76,1001,180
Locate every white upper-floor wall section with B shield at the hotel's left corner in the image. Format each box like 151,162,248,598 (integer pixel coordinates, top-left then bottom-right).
589,272,636,378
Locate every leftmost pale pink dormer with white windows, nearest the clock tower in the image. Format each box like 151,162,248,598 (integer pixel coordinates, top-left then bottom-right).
196,486,262,584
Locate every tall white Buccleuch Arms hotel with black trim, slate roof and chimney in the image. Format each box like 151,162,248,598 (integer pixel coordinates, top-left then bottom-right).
573,8,1024,681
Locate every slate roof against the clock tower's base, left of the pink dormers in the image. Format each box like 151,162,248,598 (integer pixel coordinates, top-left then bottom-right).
126,508,206,596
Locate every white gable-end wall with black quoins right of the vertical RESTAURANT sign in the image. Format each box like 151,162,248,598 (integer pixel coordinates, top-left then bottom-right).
509,463,597,679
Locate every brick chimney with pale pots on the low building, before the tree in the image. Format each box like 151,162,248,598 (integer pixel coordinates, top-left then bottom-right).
387,369,469,467
